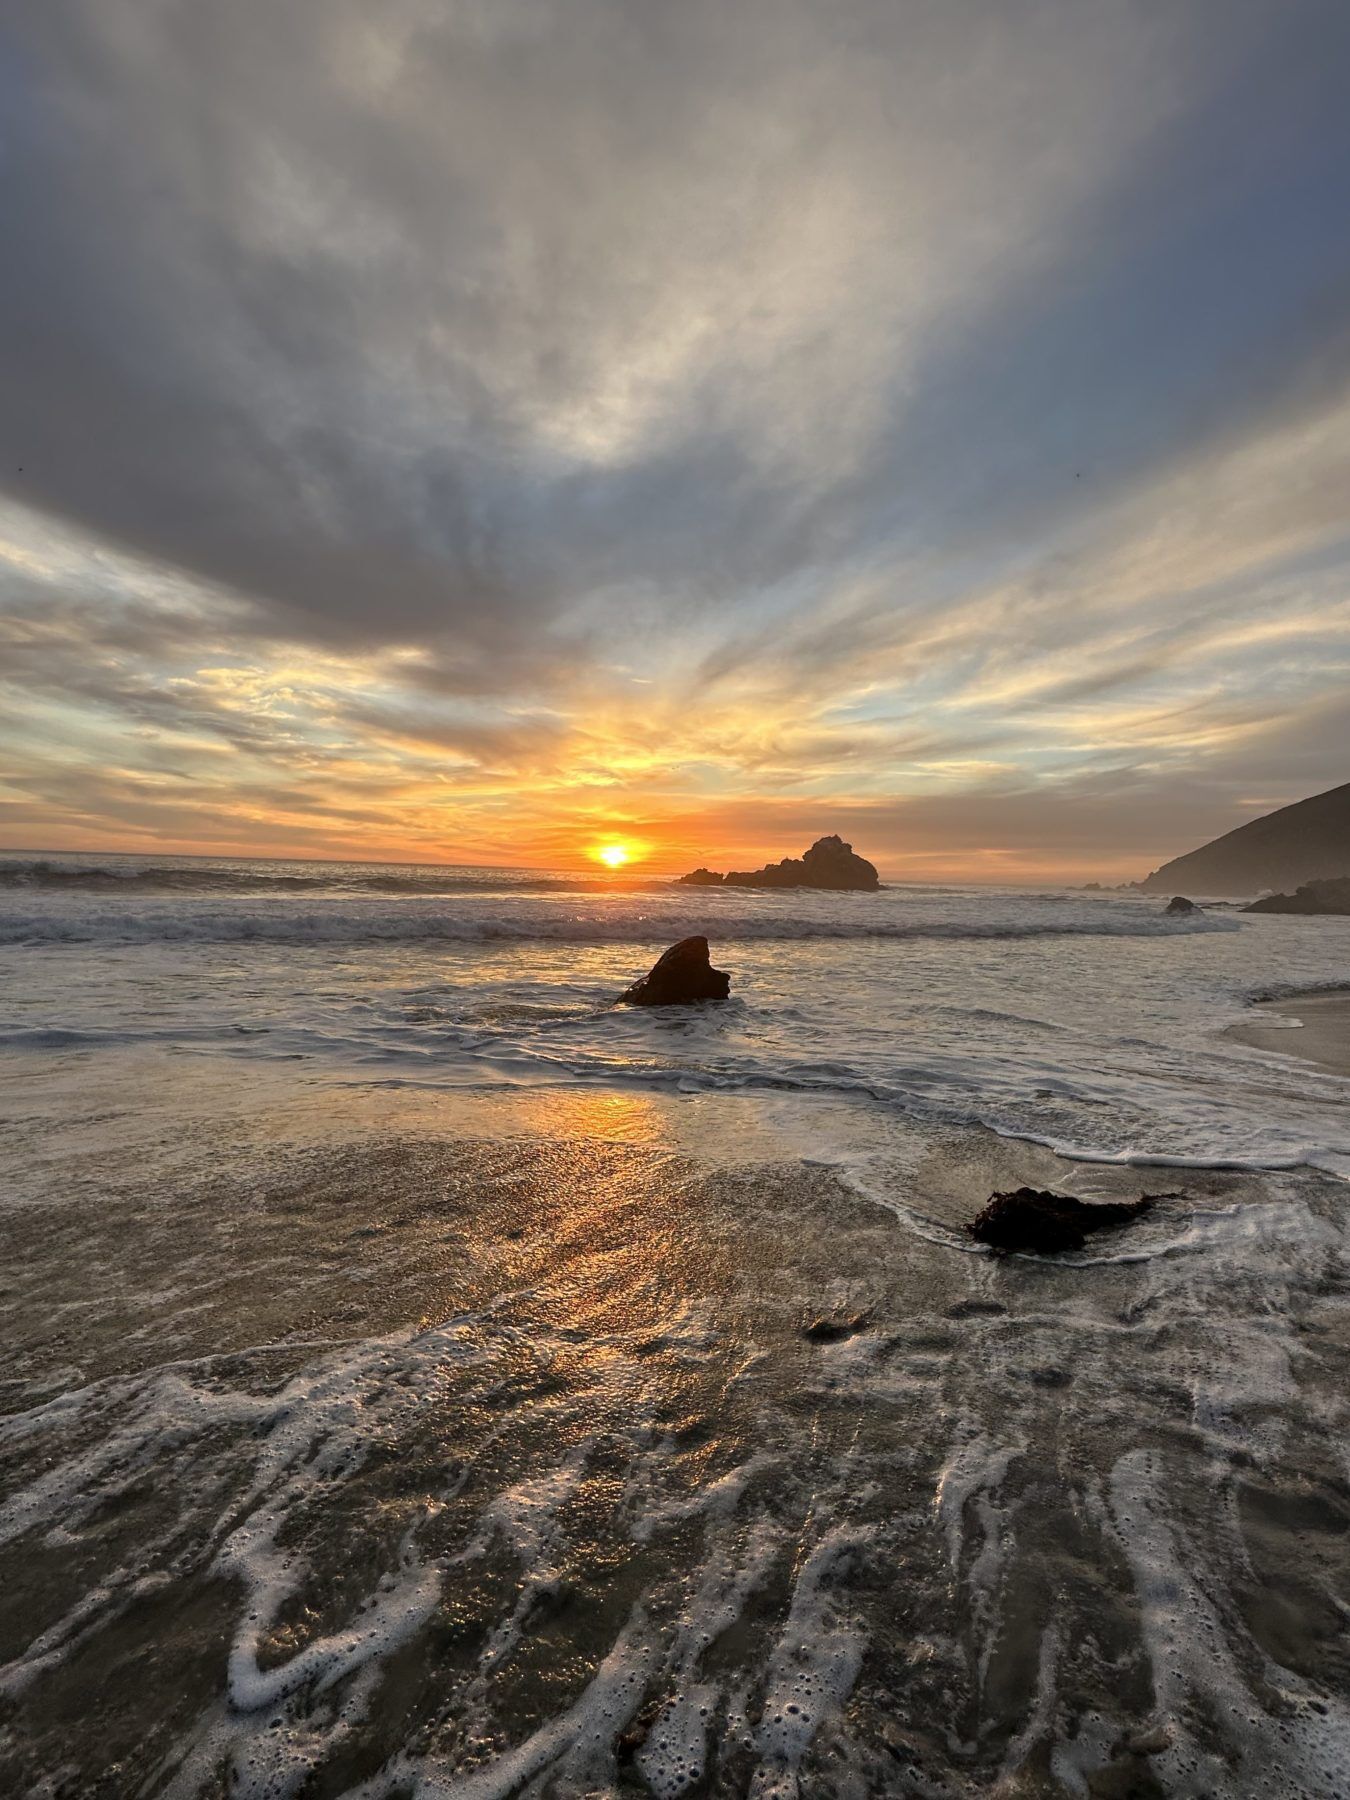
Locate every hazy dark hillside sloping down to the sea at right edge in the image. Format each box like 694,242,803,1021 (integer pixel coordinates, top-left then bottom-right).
1139,781,1350,895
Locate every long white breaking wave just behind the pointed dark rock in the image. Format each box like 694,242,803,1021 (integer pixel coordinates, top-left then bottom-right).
0,902,1242,947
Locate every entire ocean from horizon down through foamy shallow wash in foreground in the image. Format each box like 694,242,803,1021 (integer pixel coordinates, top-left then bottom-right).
0,853,1350,1800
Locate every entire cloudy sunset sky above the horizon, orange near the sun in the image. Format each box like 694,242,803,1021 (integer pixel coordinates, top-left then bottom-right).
0,0,1350,882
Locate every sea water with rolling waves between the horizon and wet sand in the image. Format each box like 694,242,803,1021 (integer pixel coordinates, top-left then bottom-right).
0,855,1350,1174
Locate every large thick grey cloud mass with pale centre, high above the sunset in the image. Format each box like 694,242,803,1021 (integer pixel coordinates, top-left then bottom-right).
0,0,1202,646
